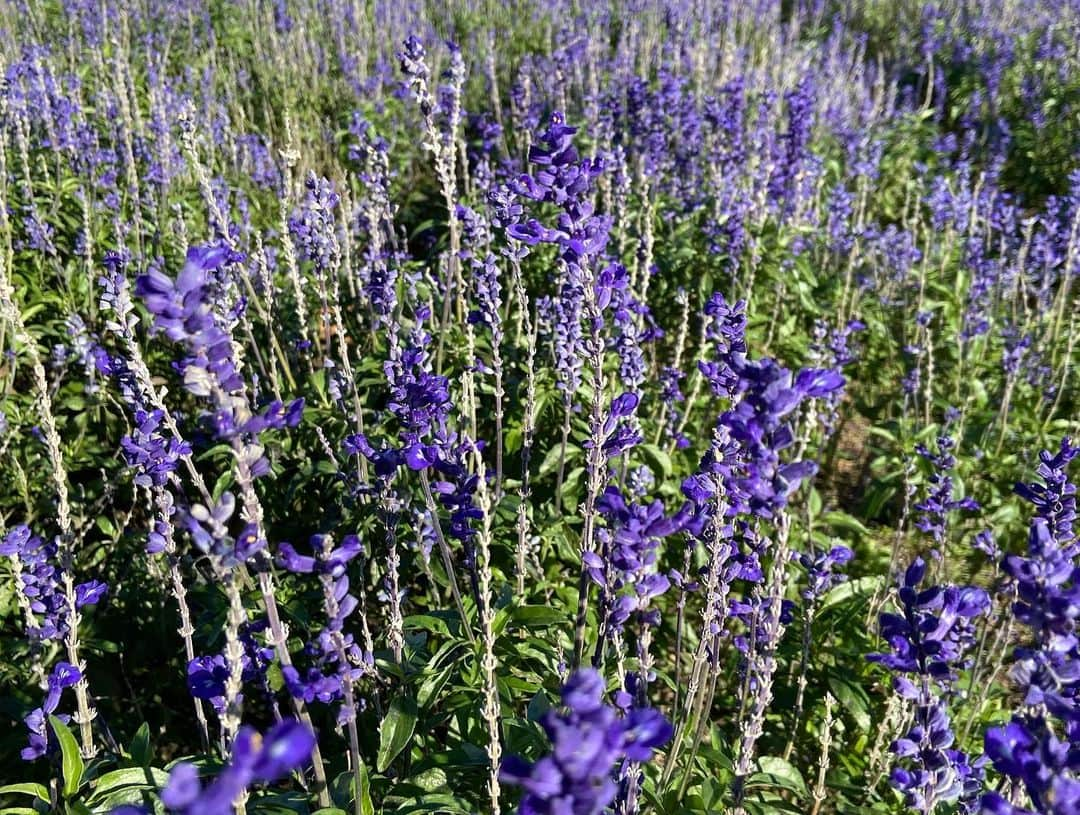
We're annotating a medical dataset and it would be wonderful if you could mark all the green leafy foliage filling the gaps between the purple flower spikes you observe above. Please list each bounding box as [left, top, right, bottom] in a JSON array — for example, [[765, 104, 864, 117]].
[[0, 0, 1080, 815]]
